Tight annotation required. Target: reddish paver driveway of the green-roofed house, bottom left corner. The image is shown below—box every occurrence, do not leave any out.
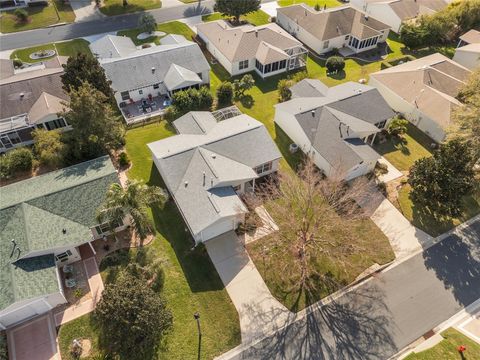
[7,313,61,360]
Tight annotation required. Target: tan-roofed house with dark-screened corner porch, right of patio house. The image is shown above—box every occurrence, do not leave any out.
[197,20,307,78]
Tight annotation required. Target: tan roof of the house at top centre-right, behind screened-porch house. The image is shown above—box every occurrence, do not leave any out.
[277,4,390,40]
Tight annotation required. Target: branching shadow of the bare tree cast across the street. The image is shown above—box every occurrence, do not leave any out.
[242,284,398,359]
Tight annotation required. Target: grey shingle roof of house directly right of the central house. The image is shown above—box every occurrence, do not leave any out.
[275,79,395,173]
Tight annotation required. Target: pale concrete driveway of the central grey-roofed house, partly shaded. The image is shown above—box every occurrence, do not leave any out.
[205,231,295,343]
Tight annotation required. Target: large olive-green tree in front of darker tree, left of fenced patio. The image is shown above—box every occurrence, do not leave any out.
[61,82,125,159]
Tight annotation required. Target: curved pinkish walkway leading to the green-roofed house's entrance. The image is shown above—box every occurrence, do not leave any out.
[54,257,104,326]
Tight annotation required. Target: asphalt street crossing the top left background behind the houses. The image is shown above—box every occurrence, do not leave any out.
[0,0,214,51]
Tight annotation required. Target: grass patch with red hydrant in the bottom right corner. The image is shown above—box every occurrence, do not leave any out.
[405,328,480,360]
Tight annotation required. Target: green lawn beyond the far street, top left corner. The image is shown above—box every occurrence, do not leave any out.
[0,0,75,33]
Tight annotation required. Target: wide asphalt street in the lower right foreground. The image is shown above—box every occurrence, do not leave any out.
[232,220,480,360]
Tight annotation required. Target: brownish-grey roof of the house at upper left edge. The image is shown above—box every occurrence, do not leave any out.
[0,60,69,119]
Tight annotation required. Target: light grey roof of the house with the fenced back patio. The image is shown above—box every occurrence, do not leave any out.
[94,35,210,92]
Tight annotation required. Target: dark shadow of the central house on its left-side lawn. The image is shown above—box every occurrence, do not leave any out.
[150,163,224,292]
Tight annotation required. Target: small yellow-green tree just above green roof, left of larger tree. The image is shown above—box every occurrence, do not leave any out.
[32,129,66,167]
